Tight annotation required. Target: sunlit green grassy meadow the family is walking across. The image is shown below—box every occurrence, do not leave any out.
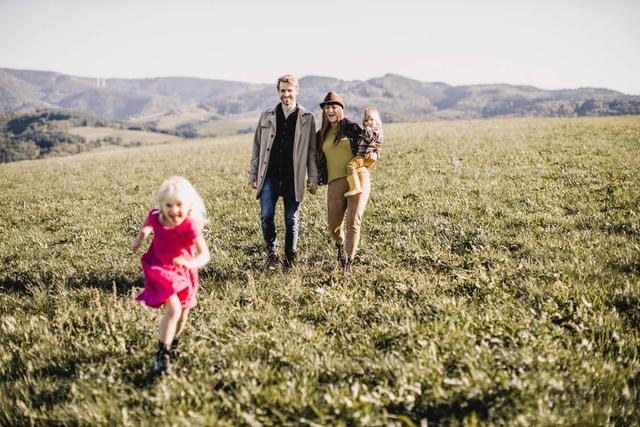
[0,117,640,427]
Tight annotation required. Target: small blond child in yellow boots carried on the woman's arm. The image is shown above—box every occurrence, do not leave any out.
[344,108,383,197]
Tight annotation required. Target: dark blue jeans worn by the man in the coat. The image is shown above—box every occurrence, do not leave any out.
[260,177,300,262]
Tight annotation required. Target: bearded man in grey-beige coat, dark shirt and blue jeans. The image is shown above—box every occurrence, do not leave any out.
[249,75,318,273]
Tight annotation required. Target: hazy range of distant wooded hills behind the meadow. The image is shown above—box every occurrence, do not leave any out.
[0,68,640,131]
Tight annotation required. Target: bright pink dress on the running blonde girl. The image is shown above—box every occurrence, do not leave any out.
[136,209,202,308]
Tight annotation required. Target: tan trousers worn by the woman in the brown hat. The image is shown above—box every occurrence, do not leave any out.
[327,171,371,259]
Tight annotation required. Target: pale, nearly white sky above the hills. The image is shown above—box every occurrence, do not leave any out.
[0,0,640,95]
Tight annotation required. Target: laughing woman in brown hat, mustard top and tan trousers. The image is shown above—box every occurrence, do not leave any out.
[317,92,377,273]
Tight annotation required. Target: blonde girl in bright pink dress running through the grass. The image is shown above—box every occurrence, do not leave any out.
[131,176,210,374]
